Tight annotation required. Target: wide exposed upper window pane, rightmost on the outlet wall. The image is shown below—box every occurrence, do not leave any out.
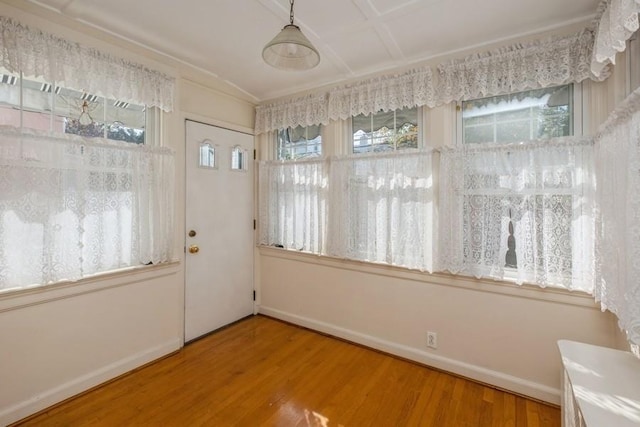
[462,85,574,144]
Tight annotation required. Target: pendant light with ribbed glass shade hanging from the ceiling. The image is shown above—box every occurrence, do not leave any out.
[262,0,320,71]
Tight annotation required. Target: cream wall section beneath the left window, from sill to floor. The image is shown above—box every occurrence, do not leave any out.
[0,263,183,425]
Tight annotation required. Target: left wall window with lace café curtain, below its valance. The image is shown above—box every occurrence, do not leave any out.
[0,69,172,291]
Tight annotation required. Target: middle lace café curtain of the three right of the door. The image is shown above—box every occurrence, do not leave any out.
[327,151,433,271]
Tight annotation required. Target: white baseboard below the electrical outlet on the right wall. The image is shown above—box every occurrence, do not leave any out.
[258,306,560,405]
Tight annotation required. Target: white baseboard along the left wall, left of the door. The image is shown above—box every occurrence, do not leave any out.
[0,338,182,426]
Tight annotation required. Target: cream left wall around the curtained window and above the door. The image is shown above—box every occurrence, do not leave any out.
[0,0,254,425]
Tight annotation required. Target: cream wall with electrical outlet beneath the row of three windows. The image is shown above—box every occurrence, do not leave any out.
[259,248,615,404]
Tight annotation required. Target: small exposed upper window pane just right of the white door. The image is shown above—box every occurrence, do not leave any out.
[276,125,322,160]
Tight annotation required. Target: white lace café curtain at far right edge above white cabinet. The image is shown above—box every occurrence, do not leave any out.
[594,89,640,350]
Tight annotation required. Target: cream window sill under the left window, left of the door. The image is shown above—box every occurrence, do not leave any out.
[0,261,180,313]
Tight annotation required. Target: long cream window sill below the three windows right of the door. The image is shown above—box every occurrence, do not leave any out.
[258,246,600,310]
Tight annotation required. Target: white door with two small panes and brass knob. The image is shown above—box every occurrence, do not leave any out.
[185,120,254,341]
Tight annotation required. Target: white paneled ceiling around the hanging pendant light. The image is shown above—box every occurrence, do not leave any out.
[22,0,600,101]
